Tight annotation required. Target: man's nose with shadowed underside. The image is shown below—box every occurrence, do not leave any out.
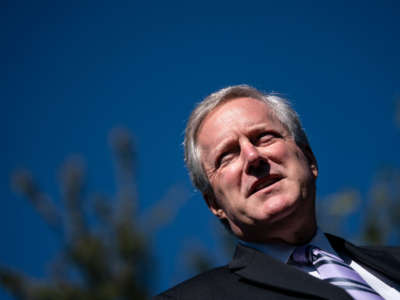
[242,141,269,177]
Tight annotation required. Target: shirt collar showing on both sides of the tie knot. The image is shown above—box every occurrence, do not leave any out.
[239,228,337,263]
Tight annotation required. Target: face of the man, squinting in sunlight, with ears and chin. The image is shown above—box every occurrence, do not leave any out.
[197,98,318,243]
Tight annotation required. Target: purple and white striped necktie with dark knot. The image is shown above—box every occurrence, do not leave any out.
[292,245,383,300]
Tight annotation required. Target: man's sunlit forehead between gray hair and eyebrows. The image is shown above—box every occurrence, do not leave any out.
[197,98,284,148]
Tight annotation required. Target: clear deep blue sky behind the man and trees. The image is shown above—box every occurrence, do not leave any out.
[0,1,400,300]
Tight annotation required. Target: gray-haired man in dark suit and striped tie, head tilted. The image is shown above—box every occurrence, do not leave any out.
[156,85,400,300]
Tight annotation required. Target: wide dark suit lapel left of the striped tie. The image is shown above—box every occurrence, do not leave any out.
[229,245,351,299]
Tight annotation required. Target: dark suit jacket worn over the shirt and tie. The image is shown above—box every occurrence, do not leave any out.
[154,235,400,300]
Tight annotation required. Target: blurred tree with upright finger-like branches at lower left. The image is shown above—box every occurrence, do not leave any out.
[0,129,177,300]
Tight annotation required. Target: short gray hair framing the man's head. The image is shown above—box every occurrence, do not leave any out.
[183,84,309,202]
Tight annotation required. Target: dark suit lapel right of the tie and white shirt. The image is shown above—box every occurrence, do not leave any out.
[326,234,400,283]
